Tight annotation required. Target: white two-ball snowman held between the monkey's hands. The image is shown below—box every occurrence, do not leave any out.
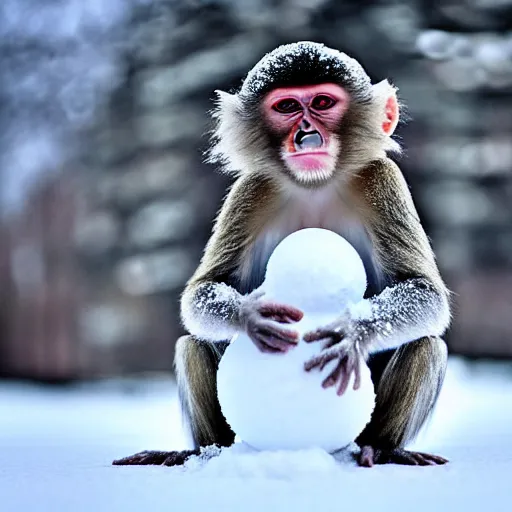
[217,229,375,452]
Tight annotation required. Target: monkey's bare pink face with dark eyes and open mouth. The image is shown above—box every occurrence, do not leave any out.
[263,84,350,185]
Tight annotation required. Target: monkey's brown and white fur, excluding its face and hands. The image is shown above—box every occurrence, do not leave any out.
[114,43,450,465]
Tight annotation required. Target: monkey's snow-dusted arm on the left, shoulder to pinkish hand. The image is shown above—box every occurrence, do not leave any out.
[181,174,302,351]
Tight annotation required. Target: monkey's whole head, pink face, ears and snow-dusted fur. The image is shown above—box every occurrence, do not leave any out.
[211,42,398,187]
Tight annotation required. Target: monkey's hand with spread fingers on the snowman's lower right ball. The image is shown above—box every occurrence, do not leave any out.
[304,315,367,396]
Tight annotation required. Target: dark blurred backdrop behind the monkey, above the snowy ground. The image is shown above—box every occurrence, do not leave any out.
[0,0,512,382]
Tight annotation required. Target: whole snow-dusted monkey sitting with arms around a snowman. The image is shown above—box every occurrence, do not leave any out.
[114,42,450,466]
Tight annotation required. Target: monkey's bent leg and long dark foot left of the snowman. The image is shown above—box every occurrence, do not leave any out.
[113,336,235,466]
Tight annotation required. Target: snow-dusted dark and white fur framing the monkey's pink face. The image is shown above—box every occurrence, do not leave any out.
[208,42,400,185]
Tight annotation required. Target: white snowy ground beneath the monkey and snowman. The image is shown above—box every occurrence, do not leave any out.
[0,359,512,512]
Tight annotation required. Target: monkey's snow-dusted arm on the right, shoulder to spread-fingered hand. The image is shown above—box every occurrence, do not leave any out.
[306,159,450,372]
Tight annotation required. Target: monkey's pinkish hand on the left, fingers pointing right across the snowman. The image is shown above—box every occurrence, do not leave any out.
[240,292,304,353]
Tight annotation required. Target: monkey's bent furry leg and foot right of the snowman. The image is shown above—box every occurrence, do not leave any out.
[356,336,448,467]
